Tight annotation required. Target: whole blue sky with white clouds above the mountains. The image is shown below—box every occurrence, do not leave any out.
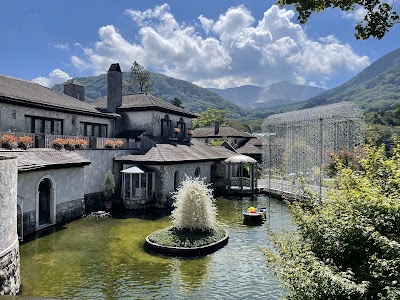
[0,0,400,88]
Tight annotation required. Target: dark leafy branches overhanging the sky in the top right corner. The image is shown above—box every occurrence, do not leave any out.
[277,0,399,40]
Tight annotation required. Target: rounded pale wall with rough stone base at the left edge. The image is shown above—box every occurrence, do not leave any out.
[0,157,21,295]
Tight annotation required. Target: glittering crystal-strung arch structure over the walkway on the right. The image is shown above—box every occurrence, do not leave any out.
[263,102,364,200]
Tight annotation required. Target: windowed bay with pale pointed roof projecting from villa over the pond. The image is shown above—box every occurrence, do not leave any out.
[121,166,155,209]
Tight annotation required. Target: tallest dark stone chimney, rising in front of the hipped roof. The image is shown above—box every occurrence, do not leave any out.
[107,63,122,112]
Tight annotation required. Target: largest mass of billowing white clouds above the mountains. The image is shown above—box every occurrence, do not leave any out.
[67,4,370,87]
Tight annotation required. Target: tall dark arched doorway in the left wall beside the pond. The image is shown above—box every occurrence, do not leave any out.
[36,176,55,227]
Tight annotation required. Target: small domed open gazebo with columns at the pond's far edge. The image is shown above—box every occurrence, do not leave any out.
[224,154,257,194]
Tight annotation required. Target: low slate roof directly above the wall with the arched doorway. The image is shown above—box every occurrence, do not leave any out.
[0,149,90,172]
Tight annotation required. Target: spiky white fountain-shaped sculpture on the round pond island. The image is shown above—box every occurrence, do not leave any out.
[171,177,217,231]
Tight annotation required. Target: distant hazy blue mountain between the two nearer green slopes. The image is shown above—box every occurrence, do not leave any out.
[208,81,326,109]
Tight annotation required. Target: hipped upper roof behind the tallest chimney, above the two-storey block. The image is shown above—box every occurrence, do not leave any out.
[91,94,197,118]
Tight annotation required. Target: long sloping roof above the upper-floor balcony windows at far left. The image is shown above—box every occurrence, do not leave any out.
[0,75,119,117]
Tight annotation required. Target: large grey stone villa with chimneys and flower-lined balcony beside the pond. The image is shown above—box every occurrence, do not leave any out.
[0,64,236,235]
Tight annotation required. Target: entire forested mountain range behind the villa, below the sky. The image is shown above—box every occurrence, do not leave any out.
[53,49,400,120]
